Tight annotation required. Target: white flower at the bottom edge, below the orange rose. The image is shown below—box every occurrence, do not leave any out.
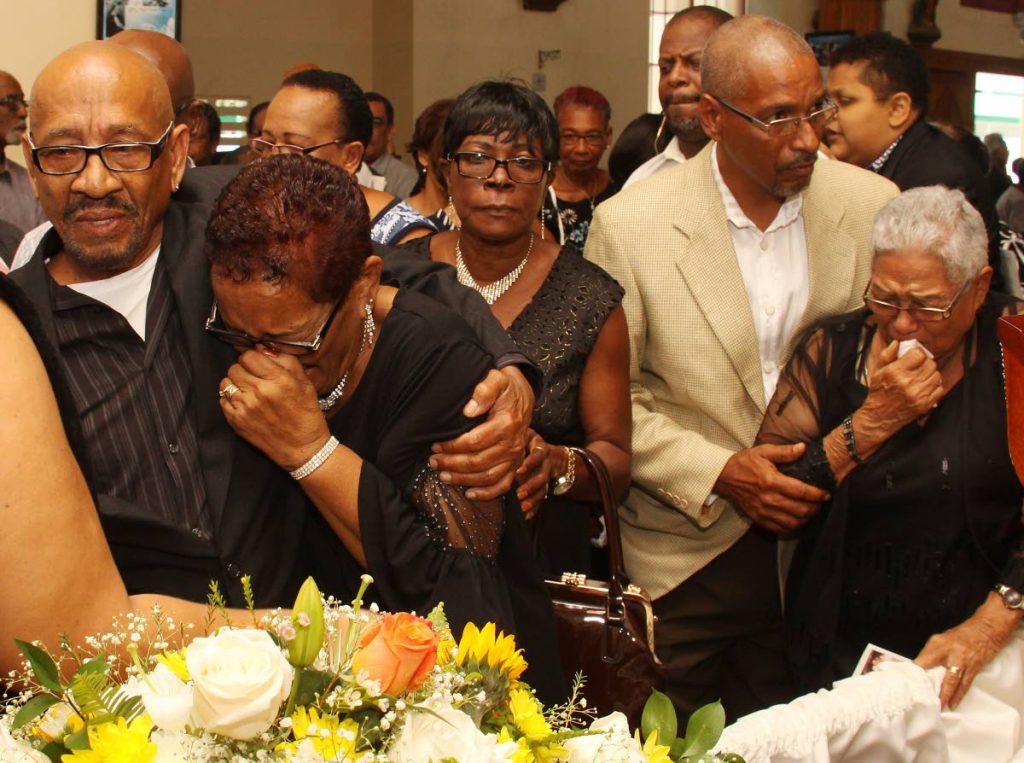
[388,700,517,763]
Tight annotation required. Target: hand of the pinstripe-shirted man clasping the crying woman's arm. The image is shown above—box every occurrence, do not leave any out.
[430,367,534,501]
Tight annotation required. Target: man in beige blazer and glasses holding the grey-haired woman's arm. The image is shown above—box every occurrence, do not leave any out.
[586,16,898,718]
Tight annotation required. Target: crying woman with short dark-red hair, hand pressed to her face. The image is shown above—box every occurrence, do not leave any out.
[201,156,559,696]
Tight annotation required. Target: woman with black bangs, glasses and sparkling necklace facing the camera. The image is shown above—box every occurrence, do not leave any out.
[408,82,631,576]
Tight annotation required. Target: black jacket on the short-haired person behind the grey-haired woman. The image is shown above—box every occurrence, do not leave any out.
[880,120,1004,291]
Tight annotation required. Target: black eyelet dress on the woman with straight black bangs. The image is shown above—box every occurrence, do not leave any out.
[509,247,625,579]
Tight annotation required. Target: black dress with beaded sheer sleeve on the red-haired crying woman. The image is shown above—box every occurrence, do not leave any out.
[301,291,564,700]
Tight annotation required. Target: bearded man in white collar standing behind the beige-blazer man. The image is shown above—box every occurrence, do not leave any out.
[623,5,732,187]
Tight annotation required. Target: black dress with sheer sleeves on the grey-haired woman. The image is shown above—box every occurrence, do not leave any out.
[758,294,1024,691]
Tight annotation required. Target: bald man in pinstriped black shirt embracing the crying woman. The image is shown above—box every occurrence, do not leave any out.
[11,42,534,605]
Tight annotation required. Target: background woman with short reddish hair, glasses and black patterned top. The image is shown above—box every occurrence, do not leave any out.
[543,85,618,252]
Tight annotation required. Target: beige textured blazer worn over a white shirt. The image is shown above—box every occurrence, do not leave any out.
[586,145,899,598]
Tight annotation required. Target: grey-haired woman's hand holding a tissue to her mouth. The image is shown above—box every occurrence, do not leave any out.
[860,341,945,435]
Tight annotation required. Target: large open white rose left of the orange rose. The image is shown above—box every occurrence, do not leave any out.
[185,628,292,739]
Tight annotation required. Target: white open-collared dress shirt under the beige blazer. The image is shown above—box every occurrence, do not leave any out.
[712,146,810,402]
